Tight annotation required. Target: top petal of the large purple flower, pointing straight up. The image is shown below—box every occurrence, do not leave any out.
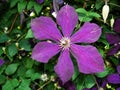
[57,5,78,37]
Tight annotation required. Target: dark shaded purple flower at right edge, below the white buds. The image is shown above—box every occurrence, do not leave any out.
[106,18,120,56]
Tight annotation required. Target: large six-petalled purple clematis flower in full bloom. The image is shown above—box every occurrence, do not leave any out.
[31,5,104,83]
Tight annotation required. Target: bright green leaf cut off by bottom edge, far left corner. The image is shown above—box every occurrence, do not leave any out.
[2,79,19,90]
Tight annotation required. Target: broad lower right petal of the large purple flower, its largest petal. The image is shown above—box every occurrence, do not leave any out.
[71,44,104,74]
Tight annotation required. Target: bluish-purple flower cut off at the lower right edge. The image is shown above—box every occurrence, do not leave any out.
[107,66,120,90]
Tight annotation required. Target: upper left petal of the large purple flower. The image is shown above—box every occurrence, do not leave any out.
[31,16,62,41]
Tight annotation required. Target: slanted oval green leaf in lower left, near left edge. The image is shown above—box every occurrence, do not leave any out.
[5,63,19,75]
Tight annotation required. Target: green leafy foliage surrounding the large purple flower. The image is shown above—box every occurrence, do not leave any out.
[0,0,120,90]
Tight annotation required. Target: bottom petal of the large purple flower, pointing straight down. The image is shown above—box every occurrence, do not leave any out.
[54,49,74,83]
